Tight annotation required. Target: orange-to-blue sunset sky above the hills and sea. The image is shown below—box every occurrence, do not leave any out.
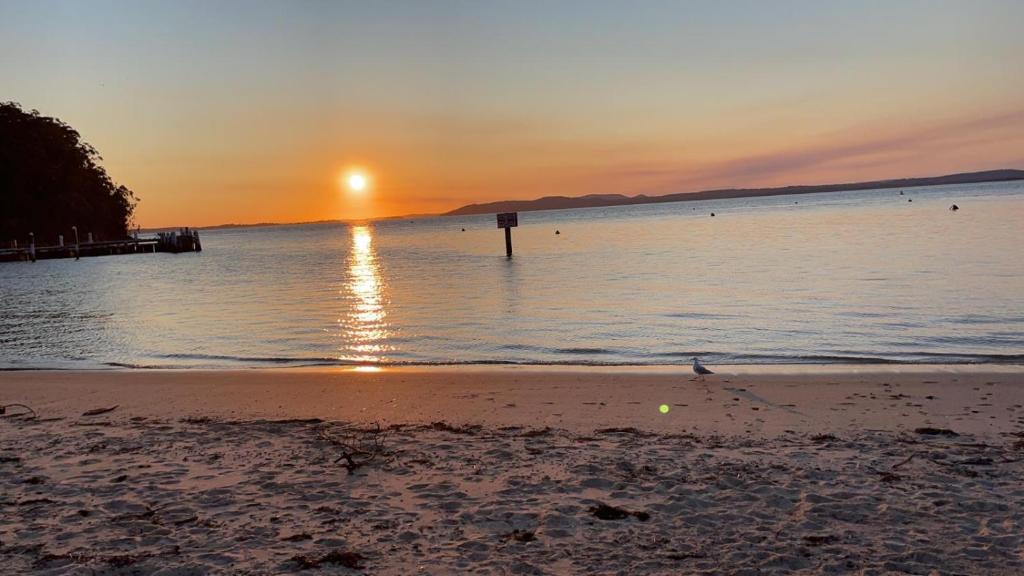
[0,0,1024,227]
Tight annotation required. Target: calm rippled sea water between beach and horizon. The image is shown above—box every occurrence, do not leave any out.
[0,182,1024,369]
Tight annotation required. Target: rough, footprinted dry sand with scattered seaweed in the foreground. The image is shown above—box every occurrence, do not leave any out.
[0,417,1024,575]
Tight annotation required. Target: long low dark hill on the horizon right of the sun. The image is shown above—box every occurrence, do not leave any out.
[444,169,1024,216]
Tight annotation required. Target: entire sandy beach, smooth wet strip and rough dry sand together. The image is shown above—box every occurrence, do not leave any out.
[0,366,1024,575]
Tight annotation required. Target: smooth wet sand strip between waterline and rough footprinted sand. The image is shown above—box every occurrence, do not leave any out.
[0,365,1024,437]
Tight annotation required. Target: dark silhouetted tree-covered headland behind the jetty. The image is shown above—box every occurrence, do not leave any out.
[0,102,137,241]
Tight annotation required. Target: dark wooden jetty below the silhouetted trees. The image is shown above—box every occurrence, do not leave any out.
[0,228,203,262]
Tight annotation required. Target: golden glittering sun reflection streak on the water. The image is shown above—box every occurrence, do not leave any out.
[338,225,388,363]
